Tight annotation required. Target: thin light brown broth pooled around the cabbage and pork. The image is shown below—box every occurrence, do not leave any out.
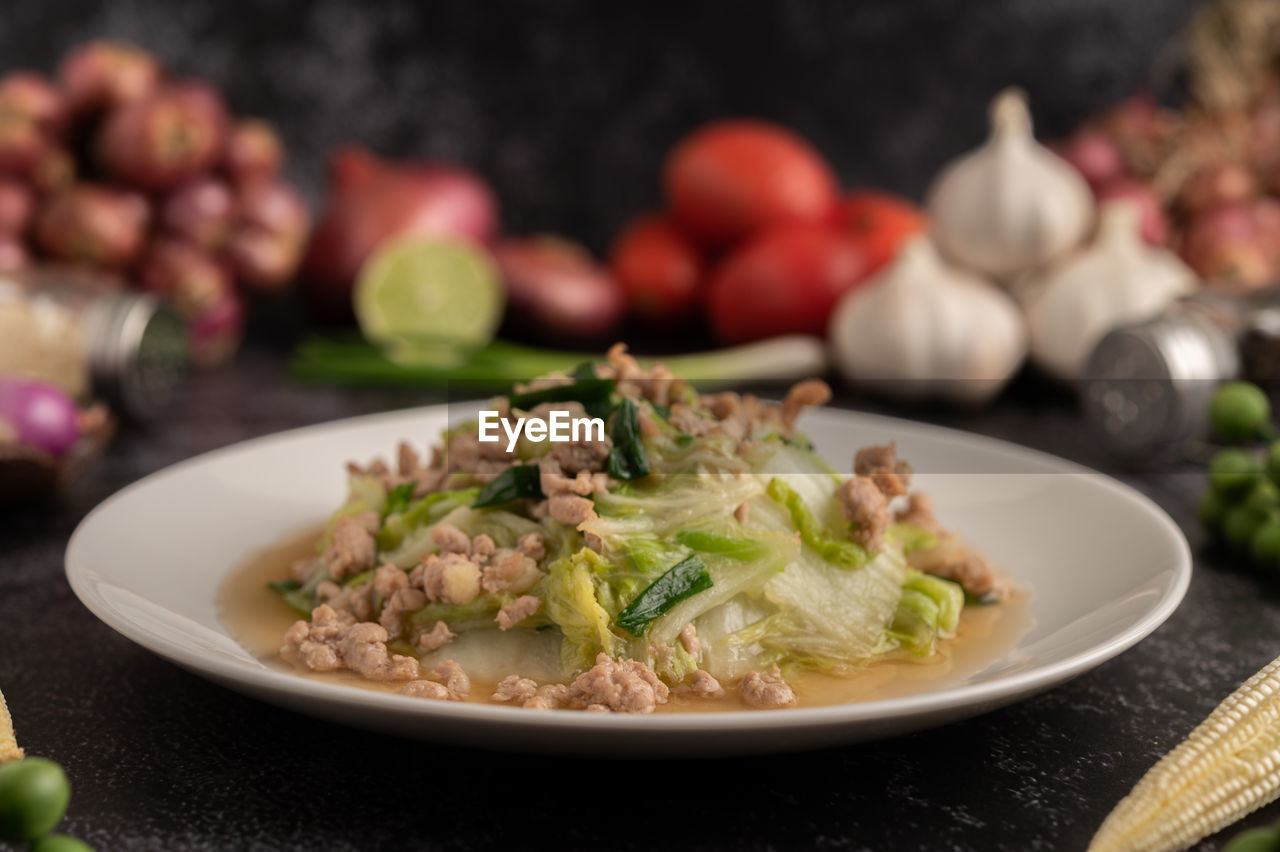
[218,525,1034,713]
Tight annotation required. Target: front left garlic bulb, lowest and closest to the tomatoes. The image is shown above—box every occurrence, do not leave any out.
[828,237,1027,402]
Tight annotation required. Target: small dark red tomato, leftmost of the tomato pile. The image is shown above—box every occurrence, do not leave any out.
[609,216,703,321]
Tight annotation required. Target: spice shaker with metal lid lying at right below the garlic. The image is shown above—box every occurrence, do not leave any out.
[1079,288,1280,462]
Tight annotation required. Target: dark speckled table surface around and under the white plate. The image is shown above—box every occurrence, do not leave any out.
[0,342,1280,849]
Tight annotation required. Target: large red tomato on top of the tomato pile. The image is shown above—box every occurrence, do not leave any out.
[663,119,838,246]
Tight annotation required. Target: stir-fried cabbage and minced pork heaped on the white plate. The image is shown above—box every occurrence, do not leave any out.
[271,344,1007,713]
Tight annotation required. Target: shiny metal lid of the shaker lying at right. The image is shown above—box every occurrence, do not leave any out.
[1080,313,1239,459]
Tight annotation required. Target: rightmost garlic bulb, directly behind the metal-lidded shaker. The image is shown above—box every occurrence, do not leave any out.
[1025,201,1196,379]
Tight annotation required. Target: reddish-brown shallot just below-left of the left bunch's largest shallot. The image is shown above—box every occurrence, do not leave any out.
[36,183,151,269]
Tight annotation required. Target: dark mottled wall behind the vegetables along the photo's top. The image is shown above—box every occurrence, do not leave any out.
[0,0,1194,249]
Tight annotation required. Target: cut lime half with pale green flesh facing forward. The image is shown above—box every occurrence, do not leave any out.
[352,238,504,363]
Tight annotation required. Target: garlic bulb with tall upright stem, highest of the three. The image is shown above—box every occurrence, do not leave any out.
[928,88,1093,281]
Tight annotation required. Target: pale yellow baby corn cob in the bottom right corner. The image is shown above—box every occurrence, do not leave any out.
[1089,649,1280,852]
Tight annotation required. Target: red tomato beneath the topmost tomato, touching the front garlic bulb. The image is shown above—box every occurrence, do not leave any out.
[708,225,870,343]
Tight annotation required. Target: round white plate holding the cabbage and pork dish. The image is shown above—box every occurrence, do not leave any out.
[67,407,1190,755]
